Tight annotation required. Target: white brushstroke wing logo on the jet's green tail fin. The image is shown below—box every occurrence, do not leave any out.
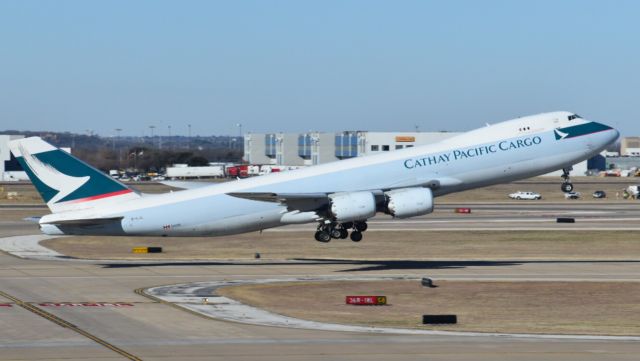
[20,146,91,203]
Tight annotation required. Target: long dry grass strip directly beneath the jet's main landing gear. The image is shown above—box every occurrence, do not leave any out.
[43,230,640,260]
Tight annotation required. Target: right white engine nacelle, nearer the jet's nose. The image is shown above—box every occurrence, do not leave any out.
[385,188,433,218]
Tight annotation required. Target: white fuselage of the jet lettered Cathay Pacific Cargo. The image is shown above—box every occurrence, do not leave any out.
[41,112,618,236]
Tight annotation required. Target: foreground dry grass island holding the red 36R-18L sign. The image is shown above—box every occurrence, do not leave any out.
[218,281,640,335]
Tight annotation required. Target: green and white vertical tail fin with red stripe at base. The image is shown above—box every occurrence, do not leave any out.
[9,137,140,213]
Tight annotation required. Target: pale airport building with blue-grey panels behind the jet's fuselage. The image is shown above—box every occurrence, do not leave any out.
[244,131,460,166]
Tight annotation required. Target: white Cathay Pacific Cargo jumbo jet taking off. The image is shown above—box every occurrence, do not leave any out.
[9,111,619,242]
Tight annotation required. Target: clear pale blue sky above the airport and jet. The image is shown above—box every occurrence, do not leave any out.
[0,0,640,135]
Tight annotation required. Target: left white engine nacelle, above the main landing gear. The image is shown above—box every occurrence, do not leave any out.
[329,192,376,222]
